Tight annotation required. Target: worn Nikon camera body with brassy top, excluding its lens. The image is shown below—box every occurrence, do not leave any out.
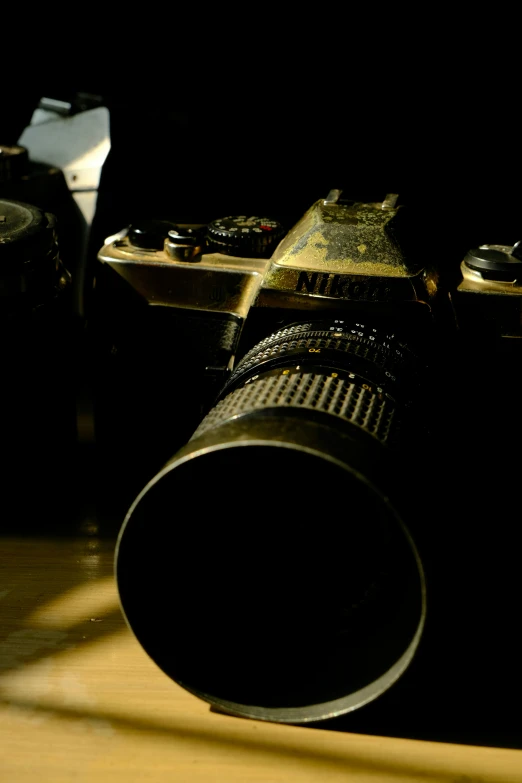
[92,190,522,512]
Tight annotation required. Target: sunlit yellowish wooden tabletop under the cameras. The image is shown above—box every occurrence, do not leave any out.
[0,521,522,783]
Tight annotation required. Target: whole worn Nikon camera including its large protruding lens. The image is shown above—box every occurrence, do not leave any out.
[94,190,522,723]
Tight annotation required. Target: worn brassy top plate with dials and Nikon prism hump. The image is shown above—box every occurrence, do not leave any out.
[98,191,441,350]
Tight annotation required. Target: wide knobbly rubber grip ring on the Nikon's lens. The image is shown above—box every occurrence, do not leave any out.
[192,369,399,446]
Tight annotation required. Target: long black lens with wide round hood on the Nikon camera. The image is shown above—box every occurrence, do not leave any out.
[117,320,425,723]
